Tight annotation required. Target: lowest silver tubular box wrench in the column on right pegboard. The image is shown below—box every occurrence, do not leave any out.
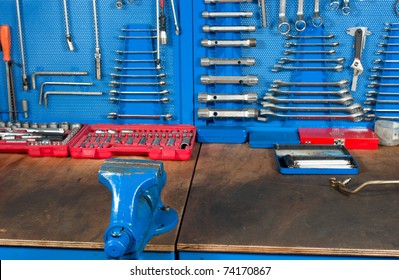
[197,108,258,119]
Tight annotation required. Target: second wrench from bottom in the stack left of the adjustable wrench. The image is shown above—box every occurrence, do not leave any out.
[261,102,363,114]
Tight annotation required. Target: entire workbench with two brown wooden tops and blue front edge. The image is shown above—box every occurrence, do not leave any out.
[0,144,399,259]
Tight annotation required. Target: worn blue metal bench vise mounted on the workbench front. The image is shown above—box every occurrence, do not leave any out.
[98,159,178,259]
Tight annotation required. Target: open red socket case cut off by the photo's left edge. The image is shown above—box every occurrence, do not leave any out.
[0,122,82,157]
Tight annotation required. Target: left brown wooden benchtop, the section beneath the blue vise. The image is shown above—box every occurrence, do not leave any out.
[0,145,199,252]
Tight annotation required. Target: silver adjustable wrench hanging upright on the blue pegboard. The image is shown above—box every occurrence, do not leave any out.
[346,27,371,91]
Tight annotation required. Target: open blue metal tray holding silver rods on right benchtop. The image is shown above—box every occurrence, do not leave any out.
[274,145,359,175]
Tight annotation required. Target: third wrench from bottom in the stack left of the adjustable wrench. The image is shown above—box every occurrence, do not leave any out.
[263,94,354,106]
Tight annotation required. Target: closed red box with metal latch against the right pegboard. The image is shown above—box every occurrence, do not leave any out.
[298,128,378,150]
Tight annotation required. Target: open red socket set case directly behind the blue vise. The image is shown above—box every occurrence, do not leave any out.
[69,124,196,160]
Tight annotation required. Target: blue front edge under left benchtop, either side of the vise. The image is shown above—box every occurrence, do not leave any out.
[0,246,175,260]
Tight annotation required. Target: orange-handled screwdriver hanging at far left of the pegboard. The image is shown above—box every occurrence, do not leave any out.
[0,25,18,122]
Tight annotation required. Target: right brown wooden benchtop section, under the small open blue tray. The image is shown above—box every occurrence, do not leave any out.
[177,145,399,257]
